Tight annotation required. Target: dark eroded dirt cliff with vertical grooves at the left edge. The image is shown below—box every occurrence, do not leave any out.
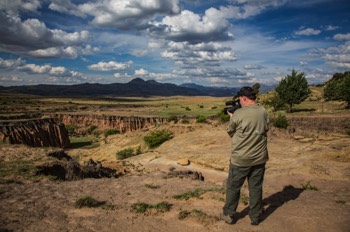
[0,118,70,148]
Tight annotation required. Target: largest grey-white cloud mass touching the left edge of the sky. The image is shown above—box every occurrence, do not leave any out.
[0,11,89,57]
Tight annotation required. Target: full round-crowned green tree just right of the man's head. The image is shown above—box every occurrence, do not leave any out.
[276,69,311,112]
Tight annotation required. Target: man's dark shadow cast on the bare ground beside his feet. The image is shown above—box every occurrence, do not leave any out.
[239,185,304,222]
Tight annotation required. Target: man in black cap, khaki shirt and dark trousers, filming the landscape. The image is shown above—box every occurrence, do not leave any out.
[221,87,269,225]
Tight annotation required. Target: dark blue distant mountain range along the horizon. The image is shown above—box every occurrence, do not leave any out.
[0,78,274,97]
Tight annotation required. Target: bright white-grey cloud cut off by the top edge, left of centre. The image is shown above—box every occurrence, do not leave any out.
[49,0,180,30]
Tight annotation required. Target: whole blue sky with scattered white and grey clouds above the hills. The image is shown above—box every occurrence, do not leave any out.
[0,0,350,87]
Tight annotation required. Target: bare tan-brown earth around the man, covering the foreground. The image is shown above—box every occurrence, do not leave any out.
[0,124,350,232]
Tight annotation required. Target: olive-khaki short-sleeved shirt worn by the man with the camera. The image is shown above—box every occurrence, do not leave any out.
[227,104,269,167]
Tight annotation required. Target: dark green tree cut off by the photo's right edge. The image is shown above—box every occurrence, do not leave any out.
[324,72,350,107]
